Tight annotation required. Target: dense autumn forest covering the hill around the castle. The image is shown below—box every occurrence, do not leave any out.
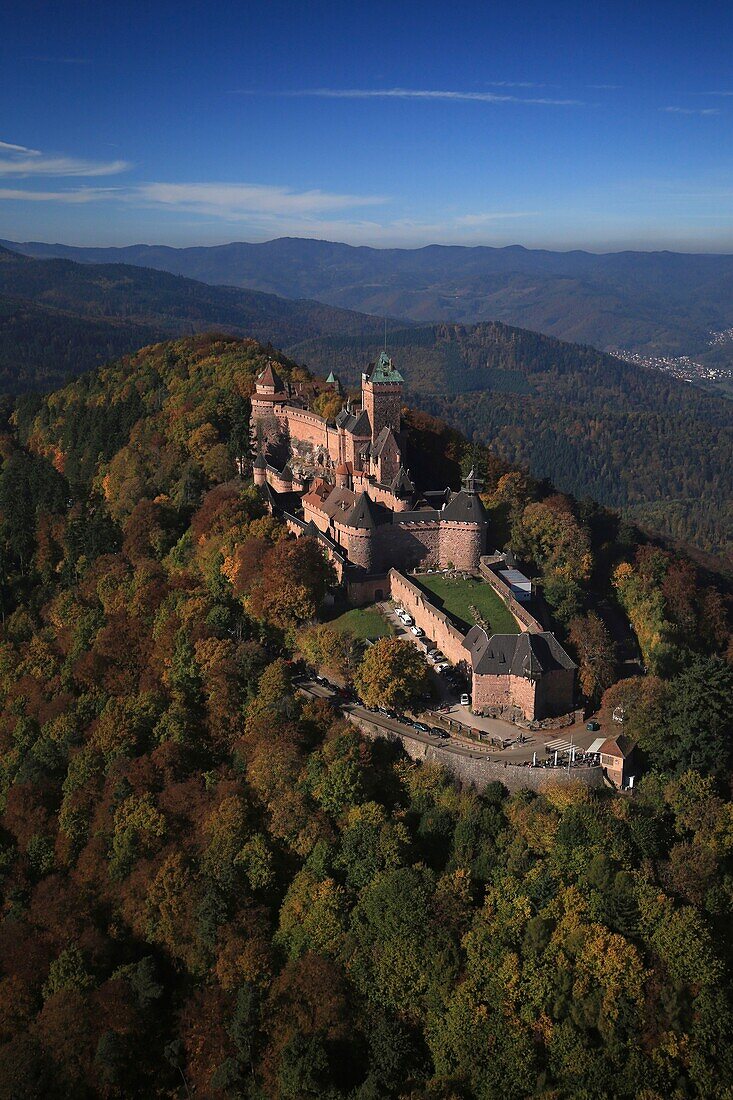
[0,337,733,1100]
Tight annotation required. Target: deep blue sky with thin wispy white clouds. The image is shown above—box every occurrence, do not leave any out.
[0,0,733,252]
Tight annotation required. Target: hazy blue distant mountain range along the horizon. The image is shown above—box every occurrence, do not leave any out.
[8,238,733,354]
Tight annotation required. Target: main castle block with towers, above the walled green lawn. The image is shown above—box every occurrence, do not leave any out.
[251,352,488,596]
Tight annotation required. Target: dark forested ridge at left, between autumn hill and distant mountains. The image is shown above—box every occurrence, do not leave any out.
[0,248,383,393]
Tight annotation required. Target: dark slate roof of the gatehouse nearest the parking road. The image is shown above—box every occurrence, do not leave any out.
[463,626,576,678]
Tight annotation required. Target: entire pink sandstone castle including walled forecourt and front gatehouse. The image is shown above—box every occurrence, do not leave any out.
[251,352,576,721]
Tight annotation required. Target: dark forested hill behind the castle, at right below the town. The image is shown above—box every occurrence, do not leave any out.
[289,323,733,560]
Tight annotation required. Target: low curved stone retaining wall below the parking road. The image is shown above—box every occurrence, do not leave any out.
[352,712,604,791]
